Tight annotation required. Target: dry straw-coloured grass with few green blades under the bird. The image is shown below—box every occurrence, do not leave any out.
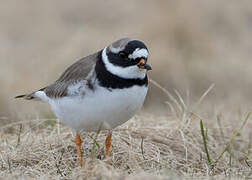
[0,81,252,179]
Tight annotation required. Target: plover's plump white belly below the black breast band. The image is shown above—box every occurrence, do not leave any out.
[48,86,147,132]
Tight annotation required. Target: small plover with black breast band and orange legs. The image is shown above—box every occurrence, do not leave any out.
[15,38,152,166]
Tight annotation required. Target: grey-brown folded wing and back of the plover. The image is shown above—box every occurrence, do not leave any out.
[41,52,100,98]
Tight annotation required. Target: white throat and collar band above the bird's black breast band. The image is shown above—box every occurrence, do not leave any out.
[102,47,147,79]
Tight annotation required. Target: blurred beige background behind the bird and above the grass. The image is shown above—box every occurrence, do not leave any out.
[0,0,252,122]
